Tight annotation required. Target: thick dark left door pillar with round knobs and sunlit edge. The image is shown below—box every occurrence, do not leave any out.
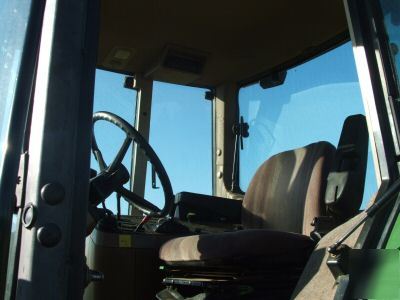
[9,0,99,299]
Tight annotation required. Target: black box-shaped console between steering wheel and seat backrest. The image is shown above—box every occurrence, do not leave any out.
[174,192,242,224]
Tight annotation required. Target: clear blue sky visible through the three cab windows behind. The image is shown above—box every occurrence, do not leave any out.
[92,43,376,212]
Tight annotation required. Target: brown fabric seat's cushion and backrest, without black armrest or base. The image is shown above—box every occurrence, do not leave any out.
[160,142,336,272]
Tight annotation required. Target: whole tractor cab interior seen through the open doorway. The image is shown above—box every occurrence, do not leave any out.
[84,0,380,300]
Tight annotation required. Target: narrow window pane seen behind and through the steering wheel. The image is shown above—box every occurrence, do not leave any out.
[91,70,136,215]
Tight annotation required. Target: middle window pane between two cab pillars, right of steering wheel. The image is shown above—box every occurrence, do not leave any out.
[145,82,212,208]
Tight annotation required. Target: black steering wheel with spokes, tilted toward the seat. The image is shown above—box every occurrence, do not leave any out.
[92,111,174,217]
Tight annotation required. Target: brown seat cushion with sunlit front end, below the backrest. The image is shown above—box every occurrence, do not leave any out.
[160,229,315,267]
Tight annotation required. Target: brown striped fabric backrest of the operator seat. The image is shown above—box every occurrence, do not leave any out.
[242,142,336,235]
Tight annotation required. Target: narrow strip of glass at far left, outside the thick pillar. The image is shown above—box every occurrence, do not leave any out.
[0,0,37,290]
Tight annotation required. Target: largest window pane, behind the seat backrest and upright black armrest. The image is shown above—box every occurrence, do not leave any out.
[239,43,377,207]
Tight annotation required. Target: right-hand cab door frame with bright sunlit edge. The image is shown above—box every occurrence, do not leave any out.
[344,0,400,253]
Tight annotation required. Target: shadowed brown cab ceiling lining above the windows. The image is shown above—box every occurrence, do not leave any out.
[98,0,348,87]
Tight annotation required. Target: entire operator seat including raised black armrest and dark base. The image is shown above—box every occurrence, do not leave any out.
[160,115,368,299]
